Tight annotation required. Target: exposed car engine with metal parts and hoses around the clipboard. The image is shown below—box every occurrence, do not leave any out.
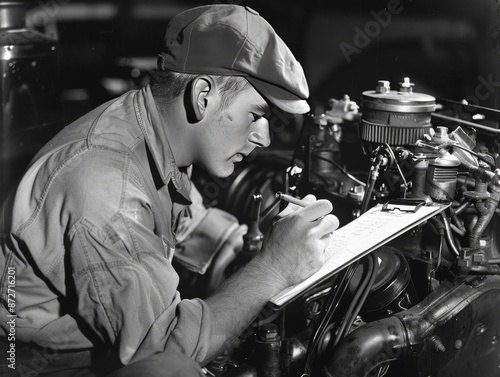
[185,77,500,377]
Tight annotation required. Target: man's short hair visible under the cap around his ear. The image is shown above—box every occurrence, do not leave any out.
[150,70,251,106]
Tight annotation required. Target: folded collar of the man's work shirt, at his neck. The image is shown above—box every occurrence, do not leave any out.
[134,85,191,201]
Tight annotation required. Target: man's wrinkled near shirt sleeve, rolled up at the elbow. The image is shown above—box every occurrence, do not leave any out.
[62,150,211,364]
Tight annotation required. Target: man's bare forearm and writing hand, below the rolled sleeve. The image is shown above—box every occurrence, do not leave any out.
[205,195,339,359]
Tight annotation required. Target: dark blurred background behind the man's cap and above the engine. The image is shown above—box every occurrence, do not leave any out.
[0,0,500,200]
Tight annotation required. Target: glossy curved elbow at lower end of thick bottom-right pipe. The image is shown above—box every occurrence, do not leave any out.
[324,317,408,377]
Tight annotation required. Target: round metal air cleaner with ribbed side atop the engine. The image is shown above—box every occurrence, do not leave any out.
[360,77,436,145]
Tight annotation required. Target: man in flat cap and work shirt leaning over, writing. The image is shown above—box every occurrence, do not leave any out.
[0,5,338,376]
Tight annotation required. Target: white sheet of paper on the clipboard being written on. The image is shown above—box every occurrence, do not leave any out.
[270,204,449,307]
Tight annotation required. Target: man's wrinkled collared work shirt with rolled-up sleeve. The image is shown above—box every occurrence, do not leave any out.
[0,86,211,364]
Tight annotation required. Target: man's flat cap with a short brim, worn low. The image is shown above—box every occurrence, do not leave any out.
[158,4,310,114]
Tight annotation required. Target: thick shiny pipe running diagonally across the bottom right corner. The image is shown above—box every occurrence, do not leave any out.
[323,276,500,377]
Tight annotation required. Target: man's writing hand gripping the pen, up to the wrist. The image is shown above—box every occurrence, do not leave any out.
[261,195,339,288]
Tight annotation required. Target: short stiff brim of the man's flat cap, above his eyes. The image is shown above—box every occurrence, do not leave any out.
[246,76,311,114]
